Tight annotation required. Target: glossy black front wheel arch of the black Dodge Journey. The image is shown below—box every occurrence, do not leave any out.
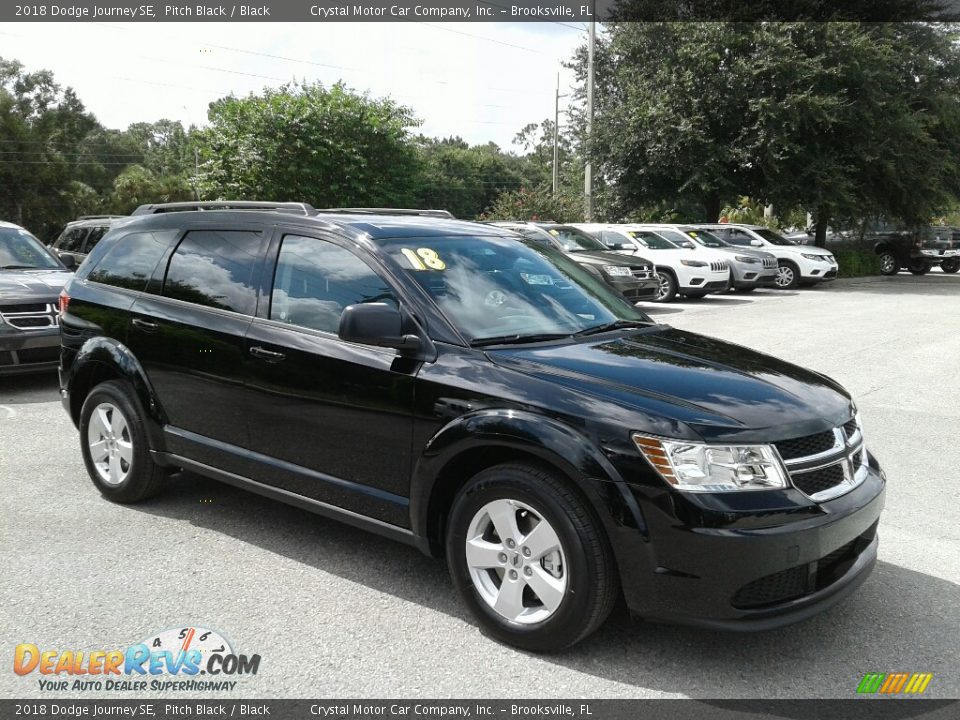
[410,408,646,546]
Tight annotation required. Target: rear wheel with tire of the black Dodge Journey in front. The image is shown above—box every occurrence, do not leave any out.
[80,380,167,503]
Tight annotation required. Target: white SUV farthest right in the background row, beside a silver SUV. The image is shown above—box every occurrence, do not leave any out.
[696,223,837,290]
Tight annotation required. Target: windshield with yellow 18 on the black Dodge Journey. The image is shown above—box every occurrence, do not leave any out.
[384,236,651,344]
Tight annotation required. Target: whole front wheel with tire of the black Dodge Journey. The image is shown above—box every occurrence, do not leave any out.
[446,463,619,652]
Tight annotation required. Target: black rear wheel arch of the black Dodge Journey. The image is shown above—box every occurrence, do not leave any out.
[65,336,167,451]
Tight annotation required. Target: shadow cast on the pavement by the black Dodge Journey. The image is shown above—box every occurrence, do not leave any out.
[130,466,960,696]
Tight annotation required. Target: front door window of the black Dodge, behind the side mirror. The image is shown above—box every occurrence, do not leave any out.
[270,235,397,333]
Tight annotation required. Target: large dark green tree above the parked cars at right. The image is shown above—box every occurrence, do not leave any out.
[578,21,960,242]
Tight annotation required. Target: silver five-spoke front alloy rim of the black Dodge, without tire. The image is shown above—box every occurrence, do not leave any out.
[465,498,568,625]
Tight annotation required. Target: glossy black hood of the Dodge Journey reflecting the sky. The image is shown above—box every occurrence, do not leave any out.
[489,326,851,442]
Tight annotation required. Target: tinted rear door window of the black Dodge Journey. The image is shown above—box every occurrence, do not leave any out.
[163,230,263,315]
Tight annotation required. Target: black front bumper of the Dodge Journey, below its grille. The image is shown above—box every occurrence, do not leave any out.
[619,461,886,630]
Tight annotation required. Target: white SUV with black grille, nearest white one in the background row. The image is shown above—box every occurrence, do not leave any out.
[575,223,730,302]
